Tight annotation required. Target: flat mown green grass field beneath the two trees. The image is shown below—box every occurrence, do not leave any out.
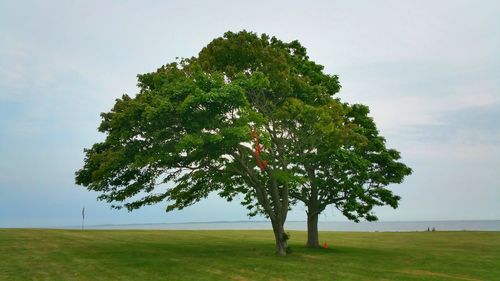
[0,229,500,281]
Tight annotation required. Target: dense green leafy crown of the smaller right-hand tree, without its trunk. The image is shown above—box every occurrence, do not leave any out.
[289,100,412,221]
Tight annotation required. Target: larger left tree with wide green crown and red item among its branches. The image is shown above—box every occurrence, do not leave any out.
[76,32,338,255]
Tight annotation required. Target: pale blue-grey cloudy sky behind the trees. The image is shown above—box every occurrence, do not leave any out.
[0,0,500,227]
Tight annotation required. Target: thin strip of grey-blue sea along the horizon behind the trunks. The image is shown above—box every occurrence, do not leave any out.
[82,220,500,232]
